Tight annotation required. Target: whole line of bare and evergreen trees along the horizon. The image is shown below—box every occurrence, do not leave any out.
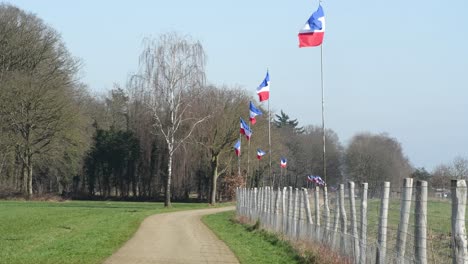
[0,4,466,206]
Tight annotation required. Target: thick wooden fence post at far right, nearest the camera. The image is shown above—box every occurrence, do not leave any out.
[451,180,468,264]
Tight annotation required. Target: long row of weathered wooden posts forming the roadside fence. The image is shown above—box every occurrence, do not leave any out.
[236,178,468,264]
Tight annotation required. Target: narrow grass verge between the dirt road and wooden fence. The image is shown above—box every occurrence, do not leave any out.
[203,211,300,263]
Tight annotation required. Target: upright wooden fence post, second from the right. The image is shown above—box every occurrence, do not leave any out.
[414,181,427,264]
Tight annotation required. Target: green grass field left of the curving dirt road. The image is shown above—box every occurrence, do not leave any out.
[0,201,216,263]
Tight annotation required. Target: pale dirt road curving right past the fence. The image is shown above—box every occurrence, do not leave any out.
[104,207,239,264]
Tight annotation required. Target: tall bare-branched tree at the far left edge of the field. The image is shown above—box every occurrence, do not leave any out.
[0,4,85,197]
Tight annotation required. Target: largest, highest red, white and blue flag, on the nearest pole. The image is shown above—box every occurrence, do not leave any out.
[298,5,325,48]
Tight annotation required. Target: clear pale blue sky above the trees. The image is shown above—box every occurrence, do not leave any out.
[8,0,468,170]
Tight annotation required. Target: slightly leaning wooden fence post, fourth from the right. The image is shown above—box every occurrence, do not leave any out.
[376,182,390,264]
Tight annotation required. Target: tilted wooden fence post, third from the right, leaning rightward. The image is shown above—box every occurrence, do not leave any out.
[395,178,413,264]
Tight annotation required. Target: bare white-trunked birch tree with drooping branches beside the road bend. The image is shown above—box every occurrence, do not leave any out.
[134,33,208,207]
